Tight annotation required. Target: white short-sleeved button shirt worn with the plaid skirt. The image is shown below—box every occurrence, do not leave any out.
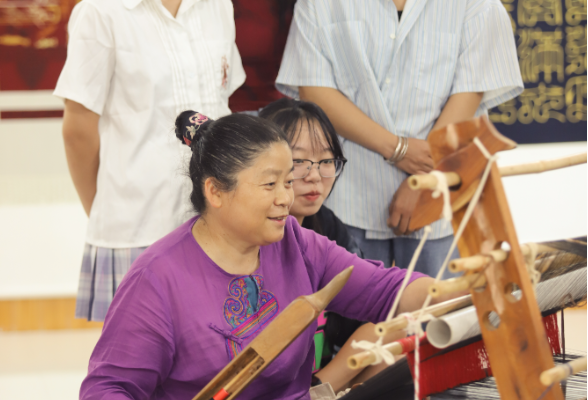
[55,0,245,248]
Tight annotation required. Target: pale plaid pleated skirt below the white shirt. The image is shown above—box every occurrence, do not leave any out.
[76,243,147,322]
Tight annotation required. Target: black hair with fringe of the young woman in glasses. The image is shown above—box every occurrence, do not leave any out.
[259,98,345,234]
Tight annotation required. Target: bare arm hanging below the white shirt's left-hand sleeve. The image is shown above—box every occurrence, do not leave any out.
[63,101,100,215]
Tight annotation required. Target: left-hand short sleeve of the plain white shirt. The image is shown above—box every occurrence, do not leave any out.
[53,1,115,115]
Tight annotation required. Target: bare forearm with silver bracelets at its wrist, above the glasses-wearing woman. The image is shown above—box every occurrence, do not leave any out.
[299,87,398,159]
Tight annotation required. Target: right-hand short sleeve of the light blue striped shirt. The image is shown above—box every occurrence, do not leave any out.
[451,0,524,110]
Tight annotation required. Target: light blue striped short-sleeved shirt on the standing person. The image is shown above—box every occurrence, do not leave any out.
[277,0,523,239]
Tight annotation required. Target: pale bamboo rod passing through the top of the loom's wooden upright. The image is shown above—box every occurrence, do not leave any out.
[408,153,588,190]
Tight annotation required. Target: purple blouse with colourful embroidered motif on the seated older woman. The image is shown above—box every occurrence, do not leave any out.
[80,217,424,400]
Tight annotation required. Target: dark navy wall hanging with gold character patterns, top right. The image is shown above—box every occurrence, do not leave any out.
[490,0,587,143]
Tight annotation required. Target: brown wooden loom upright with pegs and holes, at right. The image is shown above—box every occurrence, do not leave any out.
[382,117,586,400]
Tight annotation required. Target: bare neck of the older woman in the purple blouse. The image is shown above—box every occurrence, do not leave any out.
[192,217,260,275]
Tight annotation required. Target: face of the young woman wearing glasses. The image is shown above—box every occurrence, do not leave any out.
[290,124,335,222]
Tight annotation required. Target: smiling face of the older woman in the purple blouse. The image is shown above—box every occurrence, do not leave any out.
[217,143,294,246]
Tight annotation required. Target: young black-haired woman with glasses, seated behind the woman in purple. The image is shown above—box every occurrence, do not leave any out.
[260,99,406,391]
